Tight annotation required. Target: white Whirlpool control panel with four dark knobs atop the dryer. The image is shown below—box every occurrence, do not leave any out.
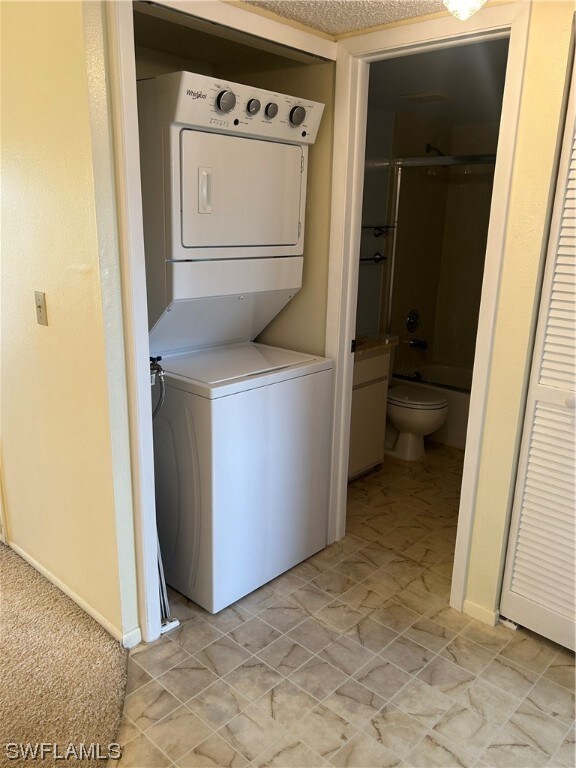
[154,72,324,144]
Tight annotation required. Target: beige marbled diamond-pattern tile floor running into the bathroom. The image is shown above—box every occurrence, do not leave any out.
[113,446,574,768]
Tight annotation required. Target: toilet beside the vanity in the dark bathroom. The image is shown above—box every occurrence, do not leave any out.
[385,384,448,461]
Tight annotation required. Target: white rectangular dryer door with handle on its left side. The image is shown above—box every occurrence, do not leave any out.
[180,129,305,254]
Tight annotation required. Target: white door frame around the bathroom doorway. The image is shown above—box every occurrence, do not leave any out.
[326,2,531,610]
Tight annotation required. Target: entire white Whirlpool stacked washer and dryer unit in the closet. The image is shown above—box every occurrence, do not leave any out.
[138,72,332,613]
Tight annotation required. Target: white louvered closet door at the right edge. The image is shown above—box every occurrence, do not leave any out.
[500,63,576,649]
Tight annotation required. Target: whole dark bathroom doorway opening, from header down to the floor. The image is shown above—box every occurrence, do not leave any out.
[347,38,508,616]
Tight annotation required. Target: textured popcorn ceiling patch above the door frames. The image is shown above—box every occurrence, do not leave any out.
[245,0,446,37]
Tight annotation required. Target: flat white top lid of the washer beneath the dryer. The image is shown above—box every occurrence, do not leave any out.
[162,342,315,386]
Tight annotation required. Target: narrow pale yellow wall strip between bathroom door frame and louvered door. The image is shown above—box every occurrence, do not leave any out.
[465,2,574,618]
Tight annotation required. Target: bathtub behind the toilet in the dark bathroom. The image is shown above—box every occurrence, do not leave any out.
[390,365,472,450]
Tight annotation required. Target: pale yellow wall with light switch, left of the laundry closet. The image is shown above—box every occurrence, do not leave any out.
[1,2,137,638]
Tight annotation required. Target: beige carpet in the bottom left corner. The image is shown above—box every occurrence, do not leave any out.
[0,543,128,768]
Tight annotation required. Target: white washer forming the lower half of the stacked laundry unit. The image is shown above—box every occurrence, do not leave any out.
[154,342,332,613]
